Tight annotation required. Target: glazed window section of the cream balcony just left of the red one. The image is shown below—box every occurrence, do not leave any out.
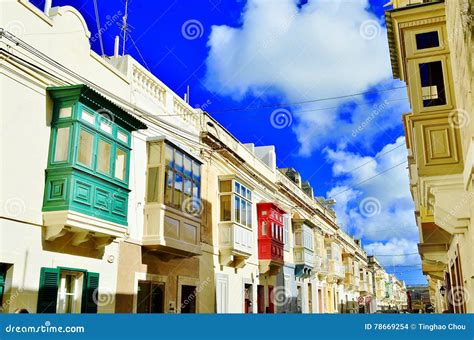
[219,179,252,227]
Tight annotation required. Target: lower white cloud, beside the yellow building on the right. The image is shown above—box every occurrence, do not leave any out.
[326,137,418,241]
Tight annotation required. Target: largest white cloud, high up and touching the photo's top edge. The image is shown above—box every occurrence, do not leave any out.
[206,0,406,155]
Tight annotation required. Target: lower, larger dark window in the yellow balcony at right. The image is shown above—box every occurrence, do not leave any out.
[419,61,446,107]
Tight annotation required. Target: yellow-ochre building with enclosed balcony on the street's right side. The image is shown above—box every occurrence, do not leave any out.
[386,0,474,313]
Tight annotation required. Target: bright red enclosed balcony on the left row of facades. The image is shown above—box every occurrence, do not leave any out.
[257,203,285,275]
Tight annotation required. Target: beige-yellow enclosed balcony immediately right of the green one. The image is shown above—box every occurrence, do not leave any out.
[142,138,203,257]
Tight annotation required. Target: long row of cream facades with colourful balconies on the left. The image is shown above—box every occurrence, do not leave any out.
[0,0,408,313]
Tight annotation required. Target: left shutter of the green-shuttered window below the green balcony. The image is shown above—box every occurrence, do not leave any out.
[36,268,59,313]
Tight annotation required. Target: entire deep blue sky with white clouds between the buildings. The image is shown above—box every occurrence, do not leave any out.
[32,0,425,283]
